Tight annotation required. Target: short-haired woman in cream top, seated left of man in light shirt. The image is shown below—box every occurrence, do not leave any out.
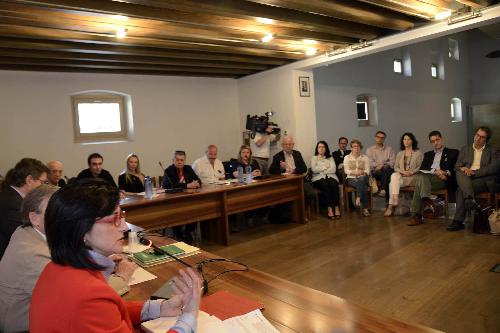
[344,139,370,216]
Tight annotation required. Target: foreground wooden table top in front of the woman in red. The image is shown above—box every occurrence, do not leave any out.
[125,236,439,333]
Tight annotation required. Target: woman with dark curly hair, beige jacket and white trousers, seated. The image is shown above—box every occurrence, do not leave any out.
[384,132,423,216]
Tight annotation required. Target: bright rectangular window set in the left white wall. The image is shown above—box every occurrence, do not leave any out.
[71,91,131,143]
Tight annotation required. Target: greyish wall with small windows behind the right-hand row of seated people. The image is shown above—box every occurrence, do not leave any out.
[314,34,470,150]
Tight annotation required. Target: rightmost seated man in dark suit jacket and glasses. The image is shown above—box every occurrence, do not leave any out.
[446,126,500,231]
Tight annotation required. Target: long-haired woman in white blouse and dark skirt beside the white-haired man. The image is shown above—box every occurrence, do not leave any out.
[311,141,340,219]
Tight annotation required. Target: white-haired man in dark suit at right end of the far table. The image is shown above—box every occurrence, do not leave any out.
[269,136,315,223]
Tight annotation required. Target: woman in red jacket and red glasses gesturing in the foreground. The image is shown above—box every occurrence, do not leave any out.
[30,179,201,333]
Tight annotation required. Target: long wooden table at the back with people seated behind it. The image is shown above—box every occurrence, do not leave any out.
[120,175,305,245]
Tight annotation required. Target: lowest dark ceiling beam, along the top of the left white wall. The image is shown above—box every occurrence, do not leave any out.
[0,56,255,75]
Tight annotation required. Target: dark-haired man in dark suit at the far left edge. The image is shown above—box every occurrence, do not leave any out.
[0,158,49,258]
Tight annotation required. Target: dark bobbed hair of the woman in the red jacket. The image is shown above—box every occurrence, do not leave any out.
[45,179,120,270]
